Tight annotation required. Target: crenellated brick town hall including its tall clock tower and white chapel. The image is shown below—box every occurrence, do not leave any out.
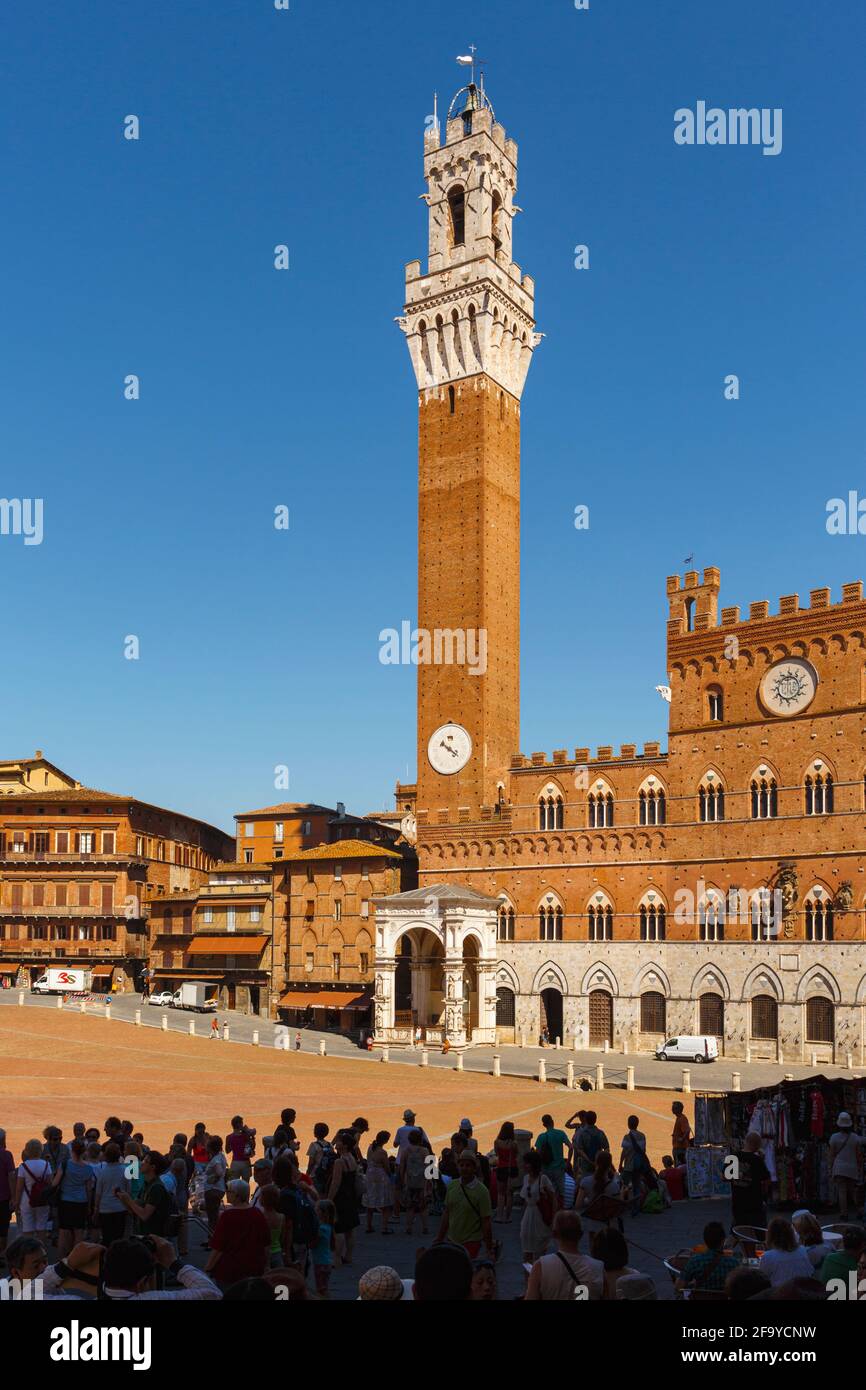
[375,73,866,1065]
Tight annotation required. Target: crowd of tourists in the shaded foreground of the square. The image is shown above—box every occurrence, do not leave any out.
[0,1101,866,1301]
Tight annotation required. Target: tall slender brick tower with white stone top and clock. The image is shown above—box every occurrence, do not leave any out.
[400,71,541,835]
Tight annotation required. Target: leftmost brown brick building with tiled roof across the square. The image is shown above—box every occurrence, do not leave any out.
[0,752,232,990]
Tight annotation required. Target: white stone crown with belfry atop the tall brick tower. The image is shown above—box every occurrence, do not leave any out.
[399,81,541,400]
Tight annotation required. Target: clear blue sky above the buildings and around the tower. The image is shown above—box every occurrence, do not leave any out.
[0,0,866,827]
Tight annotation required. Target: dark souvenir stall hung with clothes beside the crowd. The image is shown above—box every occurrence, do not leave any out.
[688,1076,866,1211]
